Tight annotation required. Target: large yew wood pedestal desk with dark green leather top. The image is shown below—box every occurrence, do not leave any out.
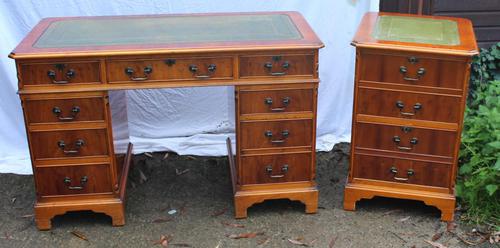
[10,12,323,230]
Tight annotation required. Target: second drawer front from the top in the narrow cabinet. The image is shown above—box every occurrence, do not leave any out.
[357,88,461,123]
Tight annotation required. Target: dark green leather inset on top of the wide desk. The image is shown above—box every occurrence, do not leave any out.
[33,14,302,48]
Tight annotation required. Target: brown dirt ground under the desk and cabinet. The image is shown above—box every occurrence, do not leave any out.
[0,143,496,248]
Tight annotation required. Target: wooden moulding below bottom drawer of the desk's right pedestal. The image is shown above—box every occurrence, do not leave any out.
[236,181,317,195]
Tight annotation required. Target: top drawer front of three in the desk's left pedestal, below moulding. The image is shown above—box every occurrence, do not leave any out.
[24,97,105,124]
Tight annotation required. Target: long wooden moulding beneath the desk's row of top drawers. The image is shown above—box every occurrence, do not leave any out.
[19,78,319,95]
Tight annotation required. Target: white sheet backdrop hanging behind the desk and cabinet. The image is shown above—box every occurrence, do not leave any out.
[0,0,379,174]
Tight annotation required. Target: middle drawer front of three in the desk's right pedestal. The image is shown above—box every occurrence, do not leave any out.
[240,119,313,149]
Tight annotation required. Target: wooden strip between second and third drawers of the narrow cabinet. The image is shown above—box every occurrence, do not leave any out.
[356,114,458,132]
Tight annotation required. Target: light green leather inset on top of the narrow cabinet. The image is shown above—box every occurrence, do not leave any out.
[372,15,460,46]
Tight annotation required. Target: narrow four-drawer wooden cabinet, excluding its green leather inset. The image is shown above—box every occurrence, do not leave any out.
[344,13,477,221]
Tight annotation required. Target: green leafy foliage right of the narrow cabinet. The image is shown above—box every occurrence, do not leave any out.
[456,43,500,229]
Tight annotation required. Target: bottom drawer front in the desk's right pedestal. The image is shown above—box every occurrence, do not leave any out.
[240,153,311,184]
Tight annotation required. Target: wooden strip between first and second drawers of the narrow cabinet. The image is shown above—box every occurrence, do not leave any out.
[358,80,463,97]
